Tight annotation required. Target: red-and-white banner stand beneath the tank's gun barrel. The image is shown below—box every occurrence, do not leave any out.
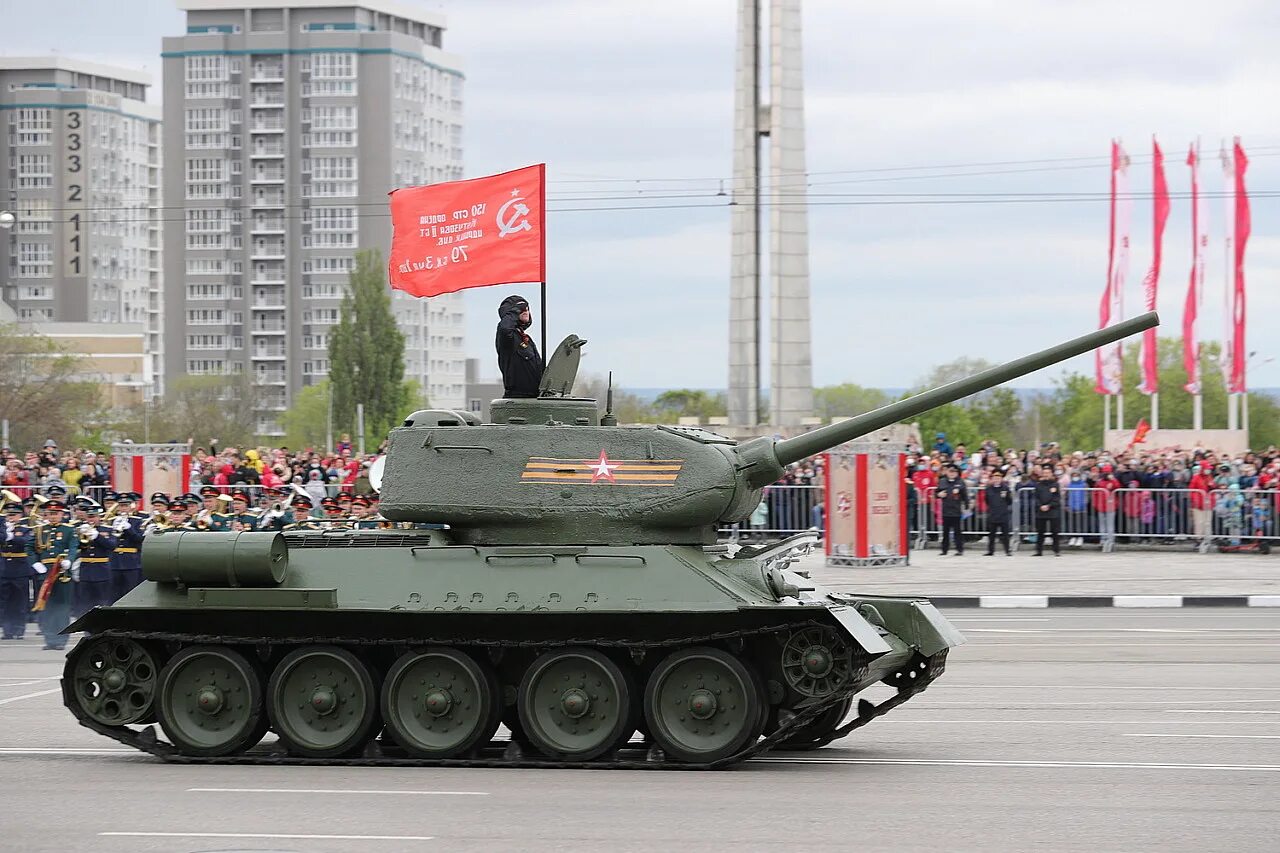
[823,441,910,566]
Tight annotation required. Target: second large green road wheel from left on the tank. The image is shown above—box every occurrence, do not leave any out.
[266,646,378,758]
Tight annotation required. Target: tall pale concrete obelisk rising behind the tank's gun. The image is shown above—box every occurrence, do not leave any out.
[728,0,813,427]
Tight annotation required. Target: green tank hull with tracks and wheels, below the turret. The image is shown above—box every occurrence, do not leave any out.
[63,532,964,768]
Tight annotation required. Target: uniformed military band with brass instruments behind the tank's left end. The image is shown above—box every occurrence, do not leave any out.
[0,485,394,649]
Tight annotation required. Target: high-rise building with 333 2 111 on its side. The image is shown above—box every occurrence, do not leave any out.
[0,56,164,396]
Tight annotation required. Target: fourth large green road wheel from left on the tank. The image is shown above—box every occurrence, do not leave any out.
[516,648,635,761]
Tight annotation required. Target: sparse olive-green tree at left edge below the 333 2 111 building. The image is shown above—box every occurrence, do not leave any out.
[0,324,104,448]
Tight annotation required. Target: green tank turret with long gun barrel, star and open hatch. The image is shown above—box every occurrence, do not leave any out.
[381,313,1160,546]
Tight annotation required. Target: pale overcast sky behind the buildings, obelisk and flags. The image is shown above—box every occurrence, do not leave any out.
[10,0,1280,387]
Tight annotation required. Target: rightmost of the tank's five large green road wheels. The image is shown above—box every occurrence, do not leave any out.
[644,646,768,763]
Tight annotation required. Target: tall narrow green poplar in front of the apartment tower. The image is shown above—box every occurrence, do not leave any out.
[329,250,412,443]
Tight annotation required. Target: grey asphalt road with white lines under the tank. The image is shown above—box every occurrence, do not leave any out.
[0,608,1280,853]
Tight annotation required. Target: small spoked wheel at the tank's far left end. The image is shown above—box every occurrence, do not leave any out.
[63,637,160,726]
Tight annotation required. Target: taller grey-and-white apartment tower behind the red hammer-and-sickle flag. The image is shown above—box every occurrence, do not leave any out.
[163,0,466,434]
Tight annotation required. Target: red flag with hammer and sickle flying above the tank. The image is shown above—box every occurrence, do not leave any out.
[388,164,547,296]
